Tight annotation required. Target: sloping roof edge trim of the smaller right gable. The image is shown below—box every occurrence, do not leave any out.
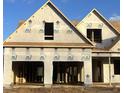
[76,8,120,36]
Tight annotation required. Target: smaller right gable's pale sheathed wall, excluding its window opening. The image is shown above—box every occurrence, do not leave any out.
[76,9,119,48]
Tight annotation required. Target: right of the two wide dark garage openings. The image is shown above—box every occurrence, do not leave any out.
[53,62,84,84]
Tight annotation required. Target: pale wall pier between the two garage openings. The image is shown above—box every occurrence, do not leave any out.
[44,59,53,85]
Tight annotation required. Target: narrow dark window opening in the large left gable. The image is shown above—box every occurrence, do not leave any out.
[45,22,54,40]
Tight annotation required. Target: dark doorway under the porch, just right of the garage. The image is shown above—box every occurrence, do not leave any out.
[92,60,103,82]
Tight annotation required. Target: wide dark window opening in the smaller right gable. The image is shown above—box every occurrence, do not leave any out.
[87,29,102,43]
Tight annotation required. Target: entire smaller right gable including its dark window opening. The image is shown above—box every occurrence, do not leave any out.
[76,9,119,48]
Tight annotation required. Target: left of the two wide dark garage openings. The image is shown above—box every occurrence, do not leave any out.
[12,62,44,84]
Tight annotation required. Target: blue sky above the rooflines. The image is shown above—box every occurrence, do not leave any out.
[3,0,120,40]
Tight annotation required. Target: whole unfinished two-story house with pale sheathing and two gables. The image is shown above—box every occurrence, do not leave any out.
[3,0,120,85]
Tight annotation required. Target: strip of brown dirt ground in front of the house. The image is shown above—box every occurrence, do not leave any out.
[3,86,120,93]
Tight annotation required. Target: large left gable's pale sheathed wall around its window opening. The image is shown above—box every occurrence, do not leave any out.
[5,1,92,46]
